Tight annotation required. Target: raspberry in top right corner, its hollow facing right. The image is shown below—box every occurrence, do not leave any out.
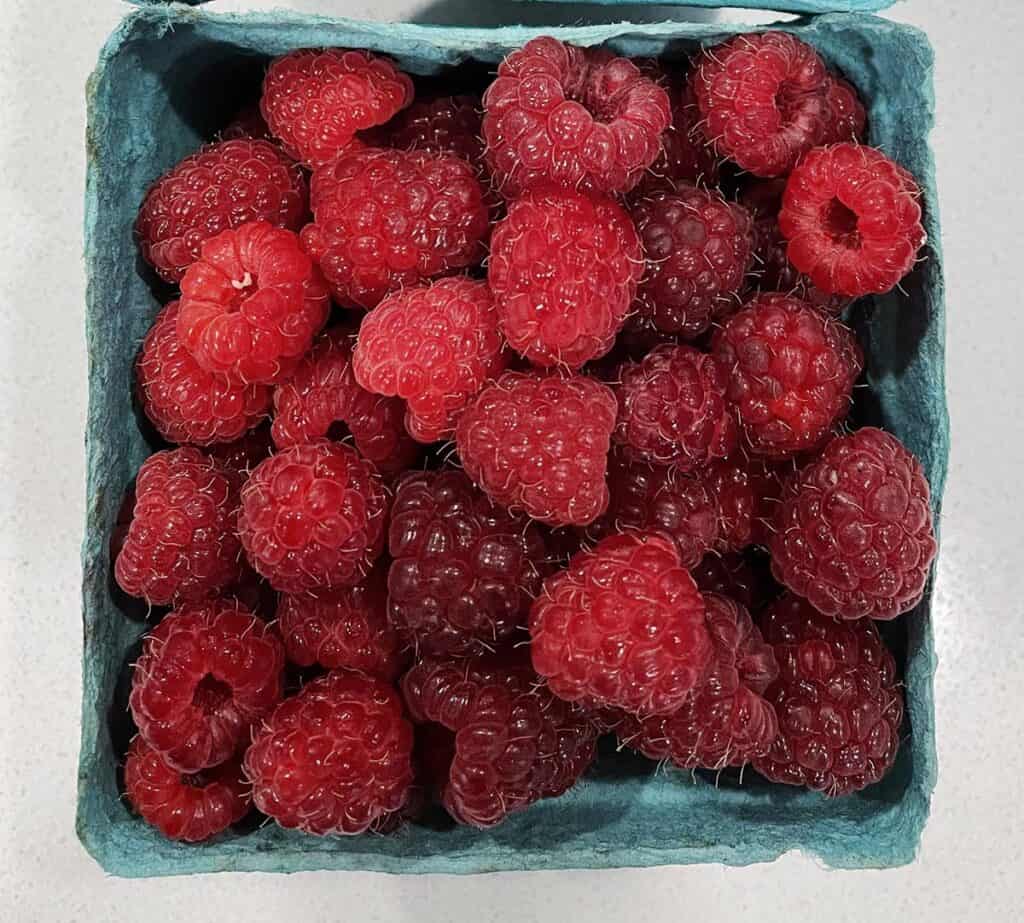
[690,32,843,176]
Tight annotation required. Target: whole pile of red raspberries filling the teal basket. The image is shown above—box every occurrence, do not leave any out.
[112,32,936,841]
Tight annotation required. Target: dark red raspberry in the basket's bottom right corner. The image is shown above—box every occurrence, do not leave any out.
[754,595,903,797]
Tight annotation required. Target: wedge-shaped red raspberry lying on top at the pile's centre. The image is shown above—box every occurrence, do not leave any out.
[456,372,616,526]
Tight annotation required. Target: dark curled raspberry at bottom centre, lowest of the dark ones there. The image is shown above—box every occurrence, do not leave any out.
[401,655,597,828]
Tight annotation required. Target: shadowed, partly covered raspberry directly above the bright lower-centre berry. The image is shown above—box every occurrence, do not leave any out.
[587,453,719,568]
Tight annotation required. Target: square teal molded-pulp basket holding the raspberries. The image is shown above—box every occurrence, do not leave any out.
[78,0,948,877]
